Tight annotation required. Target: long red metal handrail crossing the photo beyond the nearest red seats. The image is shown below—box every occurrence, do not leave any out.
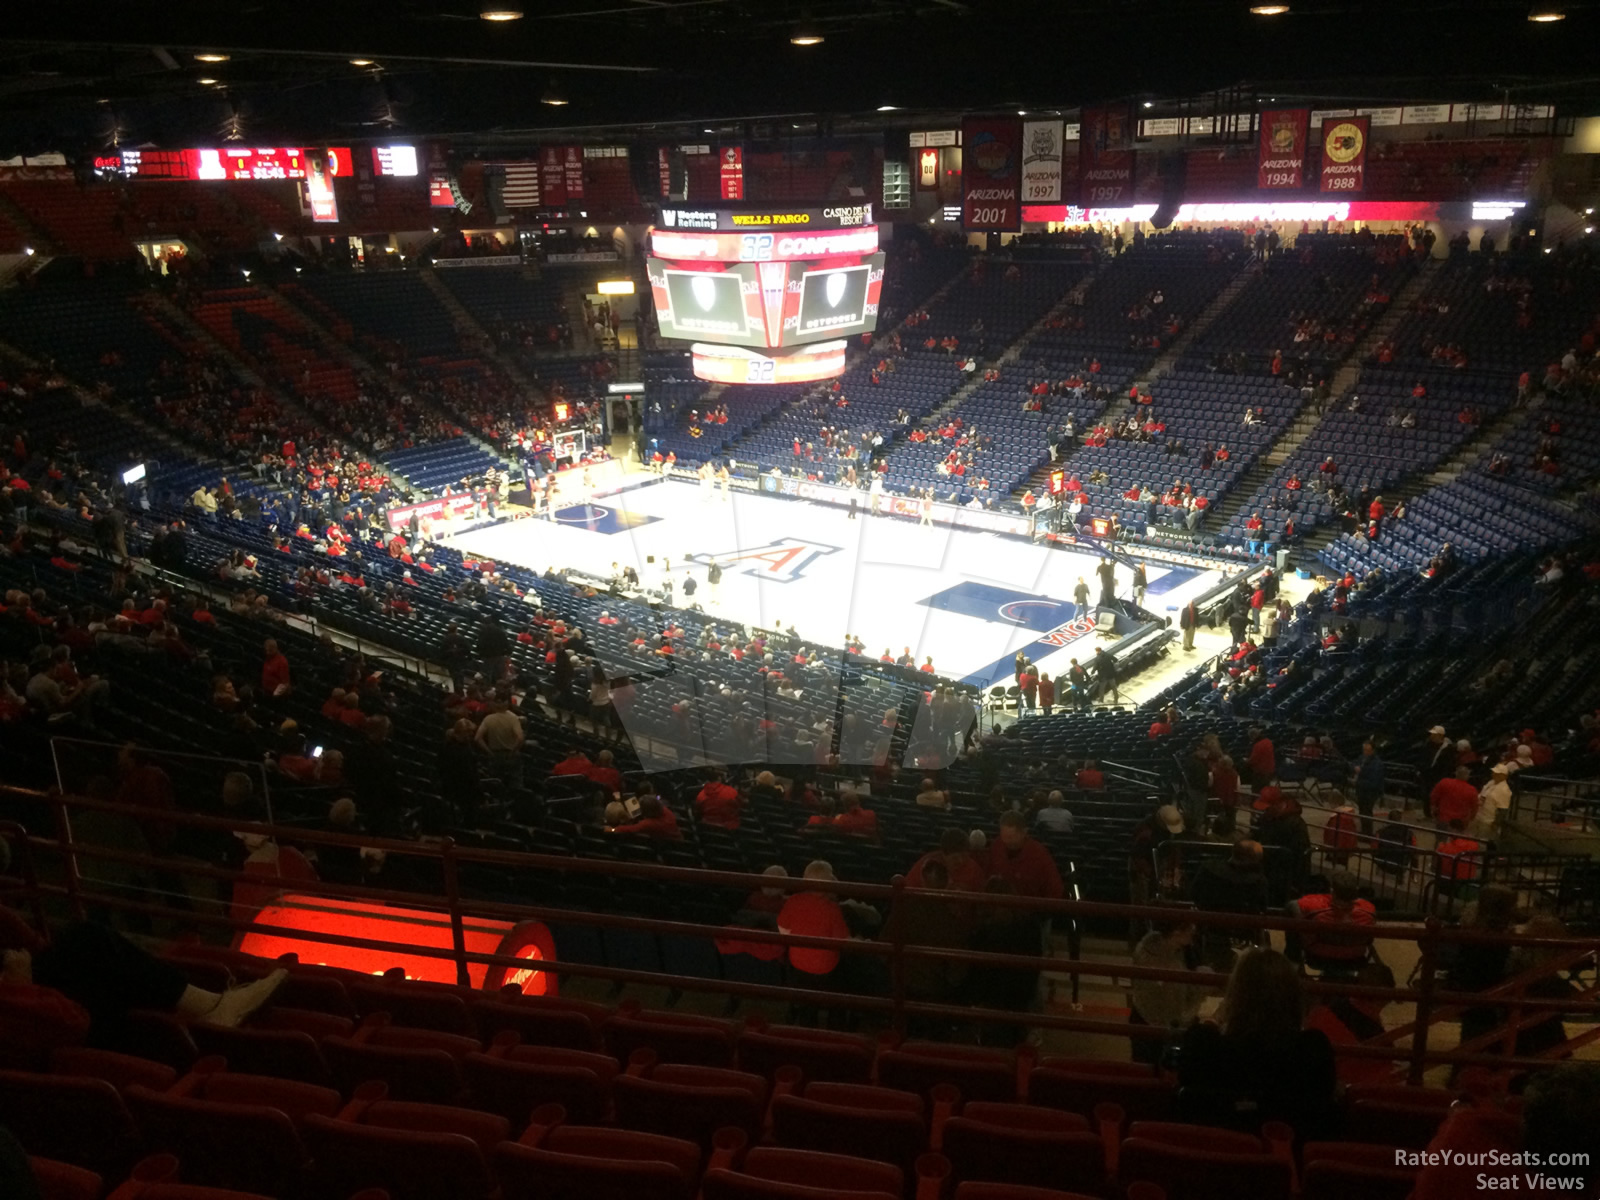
[0,786,1600,1082]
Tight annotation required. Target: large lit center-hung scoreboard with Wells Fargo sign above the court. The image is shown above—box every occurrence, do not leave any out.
[646,205,883,382]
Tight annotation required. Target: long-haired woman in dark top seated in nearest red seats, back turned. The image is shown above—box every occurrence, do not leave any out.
[1178,947,1336,1139]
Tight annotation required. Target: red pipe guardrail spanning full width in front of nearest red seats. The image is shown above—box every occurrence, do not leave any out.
[0,786,1600,1083]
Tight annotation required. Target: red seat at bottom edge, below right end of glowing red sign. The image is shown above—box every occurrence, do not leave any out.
[494,1125,701,1200]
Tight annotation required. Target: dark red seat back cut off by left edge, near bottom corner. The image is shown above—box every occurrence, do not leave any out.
[0,1070,139,1179]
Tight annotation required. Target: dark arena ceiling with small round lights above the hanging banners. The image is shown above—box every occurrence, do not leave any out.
[0,0,1600,157]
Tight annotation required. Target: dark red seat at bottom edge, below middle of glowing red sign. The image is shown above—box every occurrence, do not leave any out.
[304,1117,496,1200]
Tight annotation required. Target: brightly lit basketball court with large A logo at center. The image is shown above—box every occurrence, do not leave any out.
[451,482,1221,688]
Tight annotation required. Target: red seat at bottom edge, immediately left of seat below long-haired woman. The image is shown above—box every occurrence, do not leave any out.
[941,1104,1106,1192]
